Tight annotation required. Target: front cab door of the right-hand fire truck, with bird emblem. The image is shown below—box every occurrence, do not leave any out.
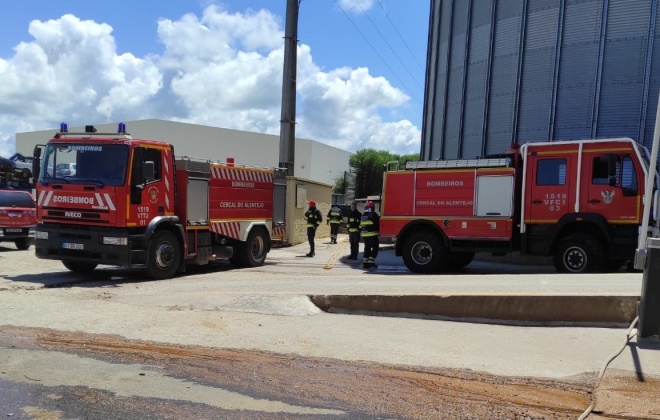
[580,153,641,223]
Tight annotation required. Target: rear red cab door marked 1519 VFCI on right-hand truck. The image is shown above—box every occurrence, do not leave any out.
[525,149,576,224]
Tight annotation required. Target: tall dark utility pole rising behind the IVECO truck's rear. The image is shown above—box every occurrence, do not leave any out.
[280,0,300,176]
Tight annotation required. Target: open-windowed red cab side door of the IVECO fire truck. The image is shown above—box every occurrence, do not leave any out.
[127,147,174,226]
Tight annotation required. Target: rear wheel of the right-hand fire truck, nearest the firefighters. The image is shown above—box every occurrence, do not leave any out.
[403,232,445,274]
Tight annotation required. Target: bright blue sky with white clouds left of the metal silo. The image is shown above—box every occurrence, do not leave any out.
[0,0,429,156]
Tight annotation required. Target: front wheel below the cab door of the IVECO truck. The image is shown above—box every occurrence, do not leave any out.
[146,230,181,280]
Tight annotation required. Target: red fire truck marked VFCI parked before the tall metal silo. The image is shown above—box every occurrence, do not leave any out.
[381,139,658,273]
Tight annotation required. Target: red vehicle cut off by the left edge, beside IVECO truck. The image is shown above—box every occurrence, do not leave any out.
[0,190,37,250]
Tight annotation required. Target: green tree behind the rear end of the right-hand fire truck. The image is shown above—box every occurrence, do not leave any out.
[348,148,419,197]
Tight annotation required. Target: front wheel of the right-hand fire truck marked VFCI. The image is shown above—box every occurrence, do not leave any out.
[553,234,605,273]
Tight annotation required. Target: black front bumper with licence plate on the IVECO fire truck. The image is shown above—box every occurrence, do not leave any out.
[34,224,131,267]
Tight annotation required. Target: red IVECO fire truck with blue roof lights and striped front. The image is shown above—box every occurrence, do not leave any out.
[34,123,286,279]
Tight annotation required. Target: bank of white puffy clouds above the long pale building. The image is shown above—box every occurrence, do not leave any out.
[0,5,420,155]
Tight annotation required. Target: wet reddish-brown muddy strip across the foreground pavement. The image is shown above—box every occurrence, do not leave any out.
[0,327,604,419]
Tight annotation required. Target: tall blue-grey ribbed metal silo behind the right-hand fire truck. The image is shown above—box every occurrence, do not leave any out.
[421,0,660,160]
